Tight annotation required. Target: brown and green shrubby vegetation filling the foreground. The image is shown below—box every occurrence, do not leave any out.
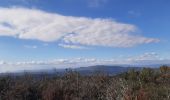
[0,66,170,100]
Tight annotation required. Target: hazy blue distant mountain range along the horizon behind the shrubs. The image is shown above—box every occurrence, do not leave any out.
[0,64,167,75]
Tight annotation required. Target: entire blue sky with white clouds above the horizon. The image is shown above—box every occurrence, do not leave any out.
[0,0,170,72]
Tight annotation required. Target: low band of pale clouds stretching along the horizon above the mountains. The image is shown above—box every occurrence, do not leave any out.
[0,52,170,73]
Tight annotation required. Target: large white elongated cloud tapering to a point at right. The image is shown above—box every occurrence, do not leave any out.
[0,7,159,48]
